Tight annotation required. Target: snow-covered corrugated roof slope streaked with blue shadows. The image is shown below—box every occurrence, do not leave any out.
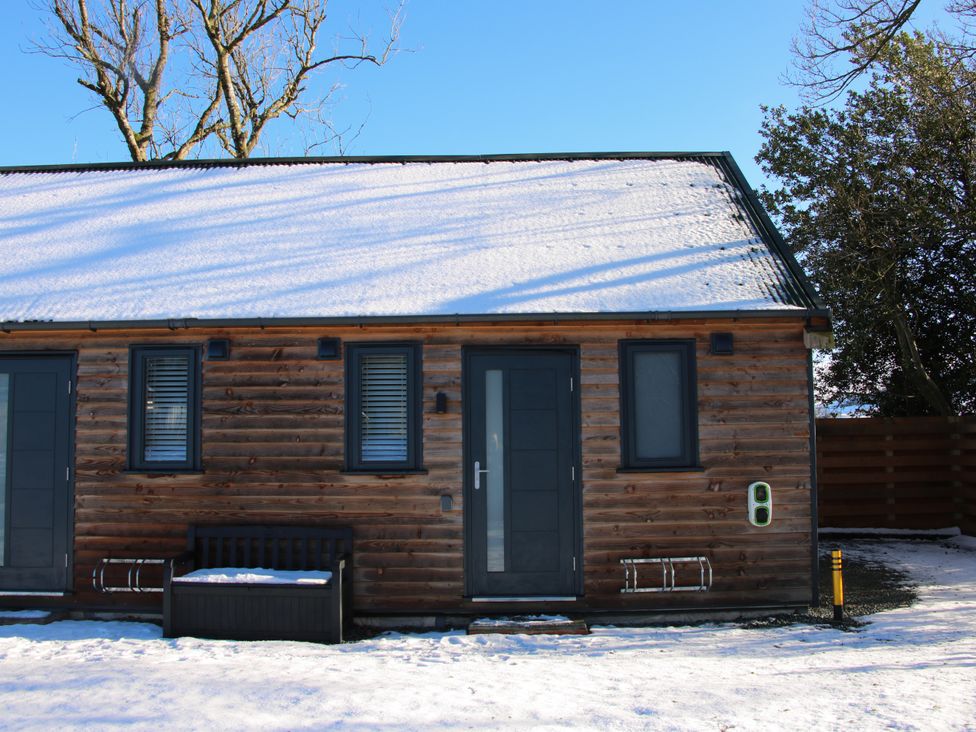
[0,156,804,321]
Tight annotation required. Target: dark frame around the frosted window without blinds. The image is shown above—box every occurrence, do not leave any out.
[618,339,701,471]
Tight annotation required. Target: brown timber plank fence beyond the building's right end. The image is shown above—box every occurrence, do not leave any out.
[817,416,976,535]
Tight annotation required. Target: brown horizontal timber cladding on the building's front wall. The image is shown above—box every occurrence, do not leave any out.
[0,318,816,613]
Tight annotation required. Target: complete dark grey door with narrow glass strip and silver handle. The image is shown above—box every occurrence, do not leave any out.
[464,351,579,597]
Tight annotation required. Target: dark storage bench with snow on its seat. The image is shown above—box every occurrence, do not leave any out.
[163,525,352,643]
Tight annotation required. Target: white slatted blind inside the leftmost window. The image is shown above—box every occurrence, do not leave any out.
[143,356,190,462]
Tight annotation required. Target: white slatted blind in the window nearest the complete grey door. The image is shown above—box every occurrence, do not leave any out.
[359,354,408,463]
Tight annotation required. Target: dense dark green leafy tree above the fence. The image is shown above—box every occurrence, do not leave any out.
[756,34,976,416]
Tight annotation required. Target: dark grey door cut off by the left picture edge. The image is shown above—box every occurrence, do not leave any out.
[0,357,72,592]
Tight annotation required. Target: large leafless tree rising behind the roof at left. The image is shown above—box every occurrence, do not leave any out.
[36,0,403,161]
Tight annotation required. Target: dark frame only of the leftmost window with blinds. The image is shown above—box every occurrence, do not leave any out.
[128,345,203,473]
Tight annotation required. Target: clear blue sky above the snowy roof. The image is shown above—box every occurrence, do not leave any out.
[0,0,952,186]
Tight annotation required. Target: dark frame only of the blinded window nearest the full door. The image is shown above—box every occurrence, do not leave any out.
[343,342,423,473]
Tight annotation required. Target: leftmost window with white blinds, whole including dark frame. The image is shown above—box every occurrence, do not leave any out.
[129,346,200,470]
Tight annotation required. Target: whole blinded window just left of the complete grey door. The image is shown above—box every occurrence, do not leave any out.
[346,344,420,470]
